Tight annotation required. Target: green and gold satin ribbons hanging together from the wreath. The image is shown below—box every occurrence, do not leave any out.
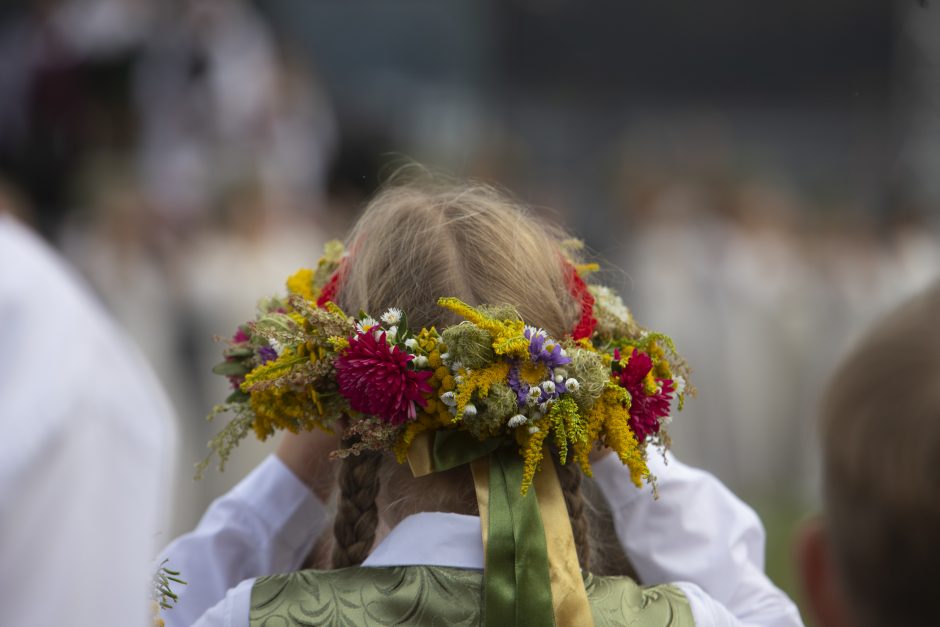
[408,431,593,627]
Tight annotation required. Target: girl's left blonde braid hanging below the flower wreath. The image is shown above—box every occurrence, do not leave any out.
[333,451,382,568]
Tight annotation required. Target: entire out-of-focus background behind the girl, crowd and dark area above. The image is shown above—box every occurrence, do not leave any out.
[0,0,940,620]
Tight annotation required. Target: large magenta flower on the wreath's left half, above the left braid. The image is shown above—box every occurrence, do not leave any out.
[336,330,434,425]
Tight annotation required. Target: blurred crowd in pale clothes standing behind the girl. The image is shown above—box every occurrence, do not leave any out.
[0,0,940,538]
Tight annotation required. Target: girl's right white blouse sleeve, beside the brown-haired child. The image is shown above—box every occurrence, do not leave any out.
[594,450,803,627]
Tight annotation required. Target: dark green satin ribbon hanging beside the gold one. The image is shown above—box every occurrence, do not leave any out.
[433,431,555,627]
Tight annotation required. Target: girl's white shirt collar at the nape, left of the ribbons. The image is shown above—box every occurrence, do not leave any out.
[362,512,483,570]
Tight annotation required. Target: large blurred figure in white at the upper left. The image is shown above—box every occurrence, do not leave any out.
[133,0,336,229]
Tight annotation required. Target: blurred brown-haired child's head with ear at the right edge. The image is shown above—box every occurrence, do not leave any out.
[800,284,940,627]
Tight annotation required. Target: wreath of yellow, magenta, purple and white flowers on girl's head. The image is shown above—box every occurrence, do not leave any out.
[200,242,690,494]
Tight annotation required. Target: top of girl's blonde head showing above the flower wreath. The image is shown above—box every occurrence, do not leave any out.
[338,182,579,337]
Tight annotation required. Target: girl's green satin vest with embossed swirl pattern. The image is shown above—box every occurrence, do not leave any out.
[250,566,694,627]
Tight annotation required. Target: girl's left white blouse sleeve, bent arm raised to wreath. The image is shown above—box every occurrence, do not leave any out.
[161,455,328,627]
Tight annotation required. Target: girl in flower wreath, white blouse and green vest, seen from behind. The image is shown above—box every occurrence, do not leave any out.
[158,184,801,627]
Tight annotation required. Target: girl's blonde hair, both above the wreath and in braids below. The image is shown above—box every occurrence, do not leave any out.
[333,180,589,568]
